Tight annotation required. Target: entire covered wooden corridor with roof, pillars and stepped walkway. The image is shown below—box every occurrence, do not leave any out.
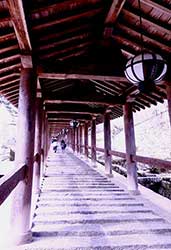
[0,0,171,250]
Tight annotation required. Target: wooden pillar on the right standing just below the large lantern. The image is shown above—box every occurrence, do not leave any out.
[123,103,138,194]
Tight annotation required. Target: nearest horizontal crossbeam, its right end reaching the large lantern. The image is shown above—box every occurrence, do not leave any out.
[38,72,128,82]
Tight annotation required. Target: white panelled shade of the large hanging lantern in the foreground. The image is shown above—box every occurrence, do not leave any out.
[125,52,167,86]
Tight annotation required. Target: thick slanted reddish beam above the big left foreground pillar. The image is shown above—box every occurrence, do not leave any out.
[7,0,32,53]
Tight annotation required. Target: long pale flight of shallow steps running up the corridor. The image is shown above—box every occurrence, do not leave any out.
[7,152,171,250]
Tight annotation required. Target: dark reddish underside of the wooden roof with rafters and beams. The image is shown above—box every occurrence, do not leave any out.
[0,0,171,134]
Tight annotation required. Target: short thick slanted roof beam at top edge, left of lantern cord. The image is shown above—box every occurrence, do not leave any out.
[105,0,126,24]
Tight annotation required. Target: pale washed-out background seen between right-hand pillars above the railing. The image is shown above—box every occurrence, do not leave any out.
[95,101,171,160]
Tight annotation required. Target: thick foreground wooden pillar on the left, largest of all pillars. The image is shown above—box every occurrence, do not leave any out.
[9,68,36,244]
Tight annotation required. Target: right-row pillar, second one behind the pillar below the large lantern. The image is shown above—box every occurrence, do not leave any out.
[91,117,96,167]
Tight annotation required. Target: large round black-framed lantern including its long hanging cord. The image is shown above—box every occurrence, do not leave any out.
[124,0,167,92]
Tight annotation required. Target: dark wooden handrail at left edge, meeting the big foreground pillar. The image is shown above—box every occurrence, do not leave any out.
[0,165,27,205]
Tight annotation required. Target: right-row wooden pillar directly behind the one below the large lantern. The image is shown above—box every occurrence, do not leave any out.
[104,112,112,177]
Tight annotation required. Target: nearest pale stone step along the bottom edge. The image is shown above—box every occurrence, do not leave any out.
[9,234,171,250]
